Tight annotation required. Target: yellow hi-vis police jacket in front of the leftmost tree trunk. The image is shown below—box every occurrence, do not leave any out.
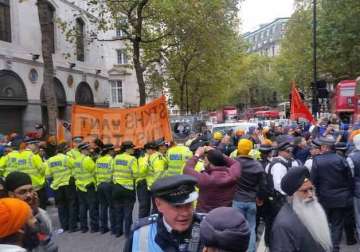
[45,153,74,190]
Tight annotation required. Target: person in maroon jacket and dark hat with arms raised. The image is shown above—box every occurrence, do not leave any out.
[184,147,241,213]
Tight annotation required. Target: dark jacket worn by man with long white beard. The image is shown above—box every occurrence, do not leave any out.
[270,203,325,252]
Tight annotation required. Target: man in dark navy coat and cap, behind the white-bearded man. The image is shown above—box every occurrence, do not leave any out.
[311,137,353,252]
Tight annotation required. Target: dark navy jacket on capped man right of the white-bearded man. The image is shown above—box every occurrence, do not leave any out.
[311,152,353,208]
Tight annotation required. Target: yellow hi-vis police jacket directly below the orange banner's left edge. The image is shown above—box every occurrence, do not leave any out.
[74,154,95,192]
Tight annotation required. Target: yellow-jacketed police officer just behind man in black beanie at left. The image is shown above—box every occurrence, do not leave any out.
[17,138,47,209]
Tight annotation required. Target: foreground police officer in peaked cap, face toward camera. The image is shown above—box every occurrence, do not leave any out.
[124,175,202,252]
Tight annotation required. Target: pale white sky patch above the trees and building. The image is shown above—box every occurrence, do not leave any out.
[240,0,294,33]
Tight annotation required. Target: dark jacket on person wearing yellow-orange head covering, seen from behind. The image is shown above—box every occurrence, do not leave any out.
[234,156,266,202]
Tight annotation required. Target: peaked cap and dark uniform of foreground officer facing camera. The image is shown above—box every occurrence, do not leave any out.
[124,175,204,252]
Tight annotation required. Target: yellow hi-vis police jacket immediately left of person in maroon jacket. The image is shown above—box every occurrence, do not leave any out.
[165,145,193,176]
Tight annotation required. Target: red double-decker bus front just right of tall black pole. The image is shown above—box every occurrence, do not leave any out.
[331,80,360,123]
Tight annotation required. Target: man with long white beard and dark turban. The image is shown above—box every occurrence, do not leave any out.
[270,167,332,252]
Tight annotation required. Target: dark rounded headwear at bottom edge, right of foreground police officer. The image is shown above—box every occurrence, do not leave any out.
[200,207,250,252]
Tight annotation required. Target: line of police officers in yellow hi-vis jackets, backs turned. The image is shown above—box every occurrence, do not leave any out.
[0,137,192,237]
